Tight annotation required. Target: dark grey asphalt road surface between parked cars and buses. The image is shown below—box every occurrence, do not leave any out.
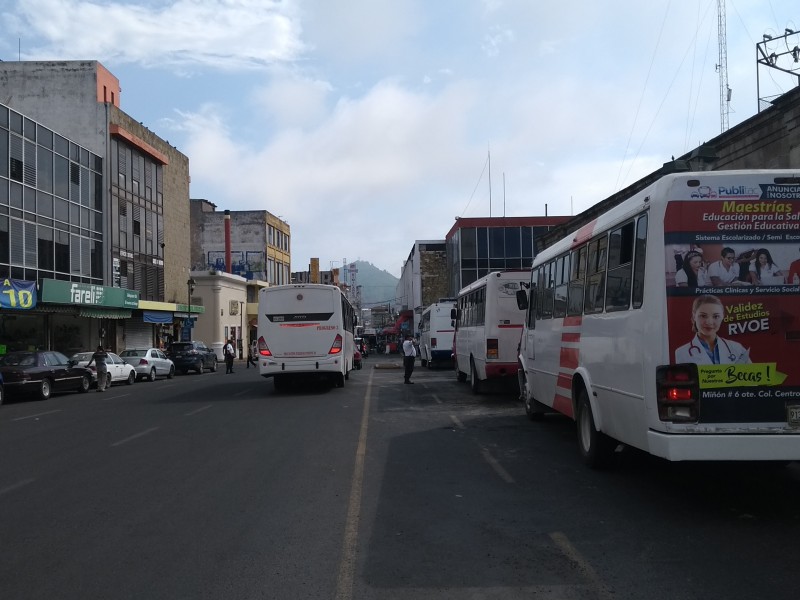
[0,355,800,600]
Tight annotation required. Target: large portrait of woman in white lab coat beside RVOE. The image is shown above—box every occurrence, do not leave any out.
[675,294,751,365]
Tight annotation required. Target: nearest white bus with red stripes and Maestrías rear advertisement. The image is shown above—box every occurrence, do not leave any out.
[518,171,800,467]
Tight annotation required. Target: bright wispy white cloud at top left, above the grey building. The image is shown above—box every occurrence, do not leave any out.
[8,0,304,70]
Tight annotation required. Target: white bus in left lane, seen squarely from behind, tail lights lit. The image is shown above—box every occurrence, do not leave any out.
[258,284,356,390]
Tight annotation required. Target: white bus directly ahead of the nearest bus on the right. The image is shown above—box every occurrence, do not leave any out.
[453,271,530,393]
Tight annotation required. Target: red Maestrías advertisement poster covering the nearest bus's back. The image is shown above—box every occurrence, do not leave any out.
[664,182,800,416]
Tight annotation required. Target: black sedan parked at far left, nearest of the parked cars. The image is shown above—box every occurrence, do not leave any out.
[0,350,92,400]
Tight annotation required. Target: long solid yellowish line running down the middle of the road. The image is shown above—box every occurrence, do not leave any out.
[336,370,375,600]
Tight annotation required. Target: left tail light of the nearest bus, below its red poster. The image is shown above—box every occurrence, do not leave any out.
[656,364,700,423]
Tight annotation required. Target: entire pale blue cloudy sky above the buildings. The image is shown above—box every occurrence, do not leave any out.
[0,0,800,276]
